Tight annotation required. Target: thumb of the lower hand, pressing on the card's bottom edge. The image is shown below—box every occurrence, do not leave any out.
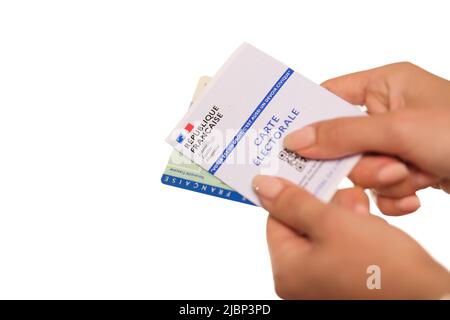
[253,175,325,237]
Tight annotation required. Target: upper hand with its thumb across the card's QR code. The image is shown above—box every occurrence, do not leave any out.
[285,63,450,215]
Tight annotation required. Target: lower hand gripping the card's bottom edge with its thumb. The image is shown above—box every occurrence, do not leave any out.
[253,176,450,299]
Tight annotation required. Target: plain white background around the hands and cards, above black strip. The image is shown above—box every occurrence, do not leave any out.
[0,0,450,298]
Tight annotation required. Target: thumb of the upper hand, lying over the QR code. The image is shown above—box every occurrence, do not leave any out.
[284,113,404,159]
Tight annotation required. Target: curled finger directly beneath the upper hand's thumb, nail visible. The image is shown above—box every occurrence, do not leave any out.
[348,155,411,188]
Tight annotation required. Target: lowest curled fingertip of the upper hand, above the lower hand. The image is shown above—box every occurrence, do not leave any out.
[372,191,420,216]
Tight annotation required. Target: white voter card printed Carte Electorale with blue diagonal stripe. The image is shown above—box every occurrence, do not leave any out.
[167,44,364,205]
